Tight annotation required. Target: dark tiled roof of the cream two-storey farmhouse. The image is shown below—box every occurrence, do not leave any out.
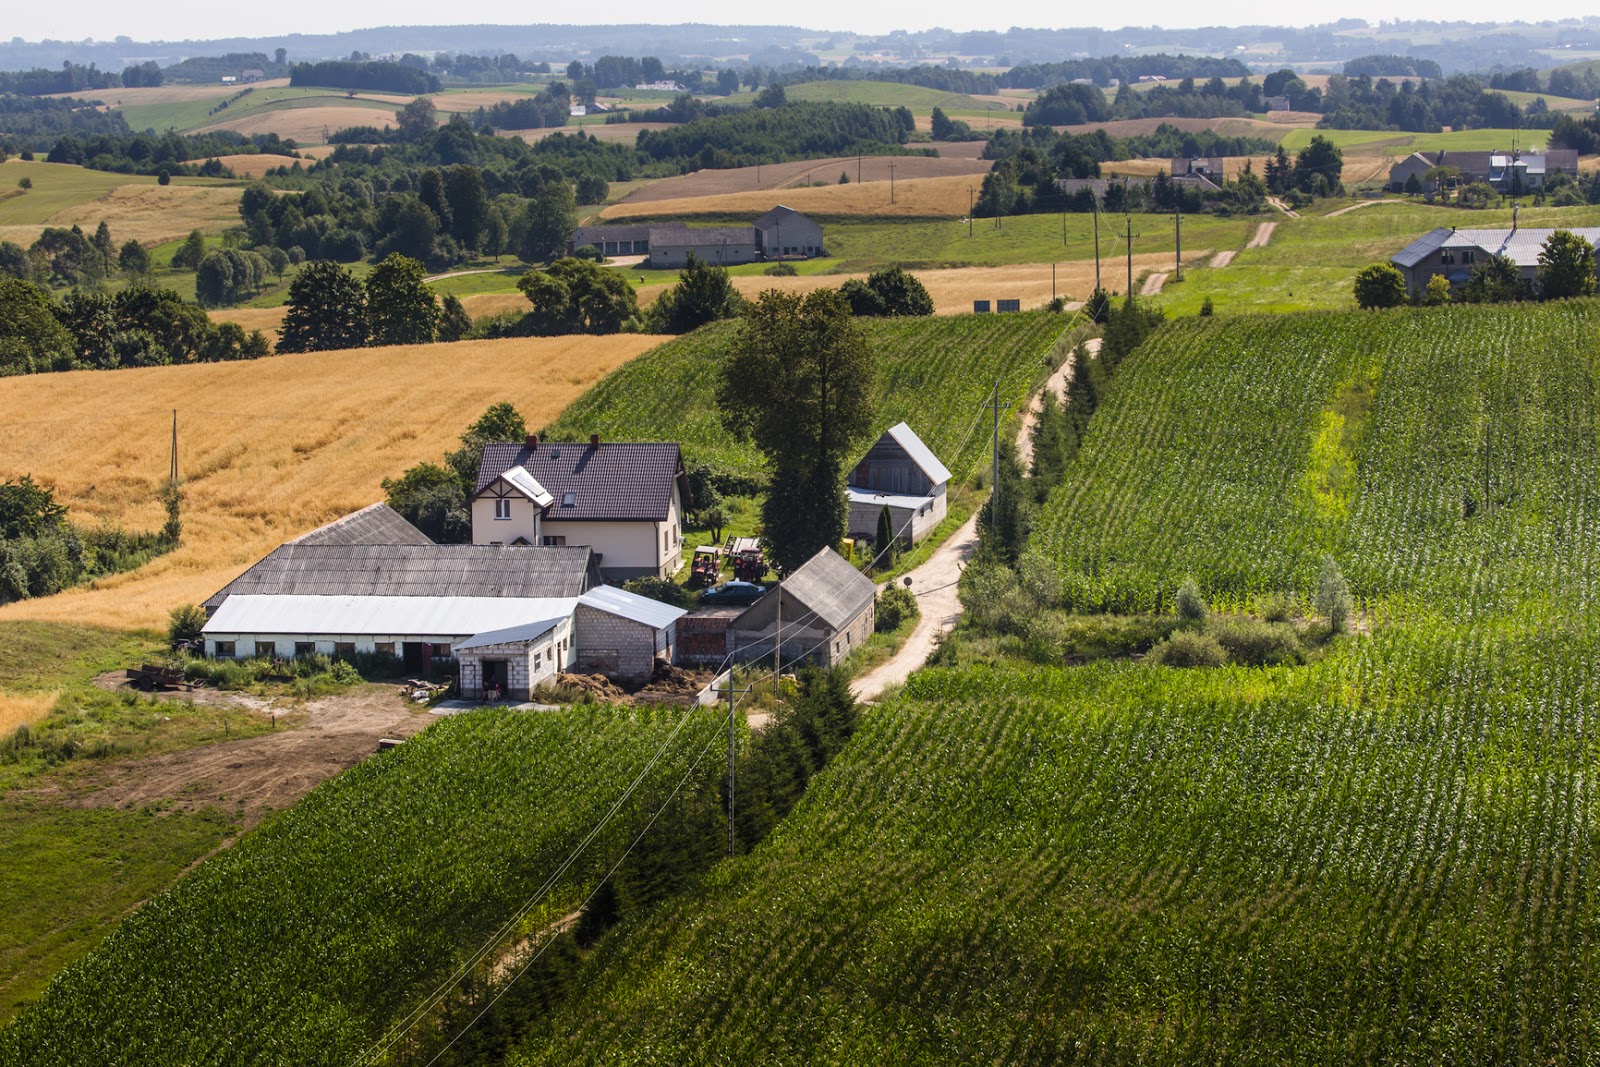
[477,442,683,523]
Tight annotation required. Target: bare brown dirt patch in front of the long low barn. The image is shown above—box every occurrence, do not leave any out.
[27,685,432,827]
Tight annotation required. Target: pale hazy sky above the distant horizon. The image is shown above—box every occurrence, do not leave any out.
[18,0,1592,42]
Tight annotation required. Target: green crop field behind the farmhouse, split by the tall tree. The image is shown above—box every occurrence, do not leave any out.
[544,312,1067,478]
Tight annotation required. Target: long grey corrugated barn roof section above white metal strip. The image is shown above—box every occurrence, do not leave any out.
[205,542,595,609]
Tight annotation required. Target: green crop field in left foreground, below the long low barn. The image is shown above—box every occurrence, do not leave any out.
[0,707,723,1065]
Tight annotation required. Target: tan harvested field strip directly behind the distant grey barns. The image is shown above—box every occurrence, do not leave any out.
[600,174,987,219]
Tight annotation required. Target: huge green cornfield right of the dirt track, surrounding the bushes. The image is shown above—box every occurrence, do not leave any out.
[512,295,1600,1064]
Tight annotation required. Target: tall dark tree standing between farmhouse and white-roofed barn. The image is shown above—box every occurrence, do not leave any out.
[717,290,874,571]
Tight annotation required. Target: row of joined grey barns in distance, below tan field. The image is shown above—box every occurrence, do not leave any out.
[566,205,824,270]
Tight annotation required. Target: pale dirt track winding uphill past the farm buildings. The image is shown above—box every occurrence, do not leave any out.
[850,338,1101,701]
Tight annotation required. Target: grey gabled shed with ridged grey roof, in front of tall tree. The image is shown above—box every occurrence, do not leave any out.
[728,549,877,667]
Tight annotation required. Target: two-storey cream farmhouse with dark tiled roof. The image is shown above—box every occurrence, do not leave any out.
[472,435,688,581]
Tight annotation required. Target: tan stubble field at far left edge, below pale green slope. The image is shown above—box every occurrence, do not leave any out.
[0,184,242,245]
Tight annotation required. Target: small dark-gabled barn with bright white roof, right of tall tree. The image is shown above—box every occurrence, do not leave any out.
[845,422,950,547]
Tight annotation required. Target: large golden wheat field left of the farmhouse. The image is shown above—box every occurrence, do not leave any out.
[0,334,662,629]
